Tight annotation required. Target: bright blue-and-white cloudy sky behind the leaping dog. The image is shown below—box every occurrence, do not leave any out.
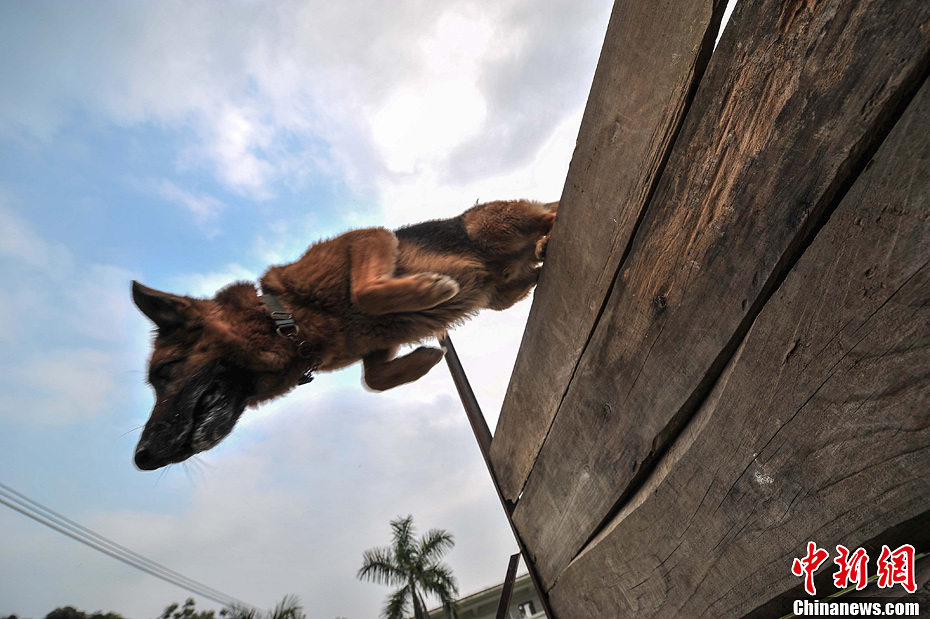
[0,0,611,619]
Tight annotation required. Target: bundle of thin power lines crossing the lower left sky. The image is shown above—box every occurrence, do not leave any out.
[0,483,255,608]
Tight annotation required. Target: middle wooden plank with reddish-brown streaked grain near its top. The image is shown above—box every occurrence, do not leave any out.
[514,0,930,586]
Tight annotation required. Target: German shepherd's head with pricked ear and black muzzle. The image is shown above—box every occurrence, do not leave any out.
[132,282,299,471]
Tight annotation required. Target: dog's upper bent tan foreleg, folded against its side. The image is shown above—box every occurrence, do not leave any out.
[349,228,459,315]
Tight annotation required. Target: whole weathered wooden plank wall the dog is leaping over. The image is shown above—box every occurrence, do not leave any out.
[491,0,930,617]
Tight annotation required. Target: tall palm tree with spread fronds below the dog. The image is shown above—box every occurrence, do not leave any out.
[358,516,459,619]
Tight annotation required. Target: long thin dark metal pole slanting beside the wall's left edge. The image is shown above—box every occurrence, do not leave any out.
[439,334,555,619]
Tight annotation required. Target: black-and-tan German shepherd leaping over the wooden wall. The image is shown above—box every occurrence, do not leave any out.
[132,200,558,470]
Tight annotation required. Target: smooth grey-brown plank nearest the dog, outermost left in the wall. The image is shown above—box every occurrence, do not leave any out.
[491,0,724,501]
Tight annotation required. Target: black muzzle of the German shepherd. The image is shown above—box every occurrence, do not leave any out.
[133,368,253,471]
